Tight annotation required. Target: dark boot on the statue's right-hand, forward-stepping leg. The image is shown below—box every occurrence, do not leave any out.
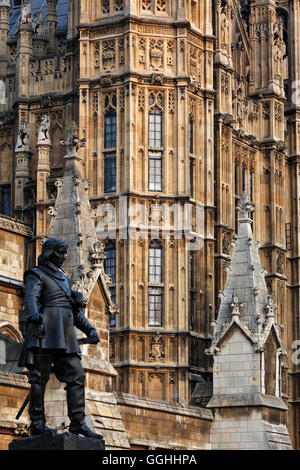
[66,385,103,439]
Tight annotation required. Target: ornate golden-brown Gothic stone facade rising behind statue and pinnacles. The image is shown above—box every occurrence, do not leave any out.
[0,0,300,448]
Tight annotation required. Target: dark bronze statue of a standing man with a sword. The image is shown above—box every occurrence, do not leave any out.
[19,238,103,439]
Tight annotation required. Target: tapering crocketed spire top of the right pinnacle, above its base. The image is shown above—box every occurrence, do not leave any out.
[209,192,278,353]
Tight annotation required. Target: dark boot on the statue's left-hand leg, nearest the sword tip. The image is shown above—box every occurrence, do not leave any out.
[29,383,56,436]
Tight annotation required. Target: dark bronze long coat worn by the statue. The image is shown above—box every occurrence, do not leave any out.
[19,262,94,366]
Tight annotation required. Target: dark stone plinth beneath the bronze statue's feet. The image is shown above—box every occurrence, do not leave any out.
[9,432,105,451]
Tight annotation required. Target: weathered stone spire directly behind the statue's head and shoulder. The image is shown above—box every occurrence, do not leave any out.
[48,122,116,313]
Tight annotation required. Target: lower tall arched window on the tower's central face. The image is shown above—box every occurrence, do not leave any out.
[148,241,163,326]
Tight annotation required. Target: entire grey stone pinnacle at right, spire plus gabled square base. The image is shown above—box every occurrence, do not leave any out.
[206,193,291,450]
